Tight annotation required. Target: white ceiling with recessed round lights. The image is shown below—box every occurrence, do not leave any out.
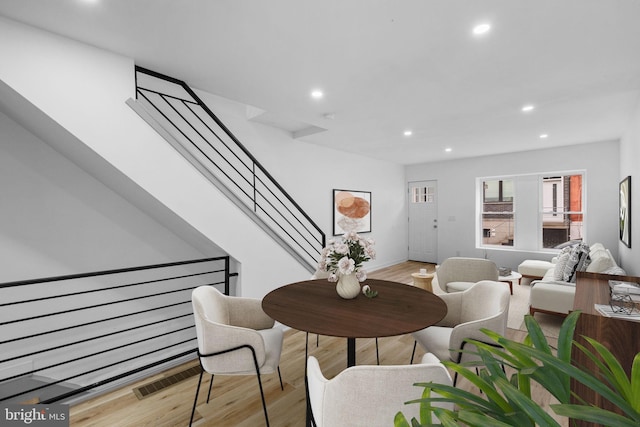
[0,0,640,164]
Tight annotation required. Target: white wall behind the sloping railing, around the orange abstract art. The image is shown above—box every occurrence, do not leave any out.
[197,91,407,271]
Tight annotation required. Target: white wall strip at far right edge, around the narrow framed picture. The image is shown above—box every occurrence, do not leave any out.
[618,100,640,276]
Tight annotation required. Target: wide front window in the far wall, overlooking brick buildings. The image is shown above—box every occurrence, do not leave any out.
[476,172,585,251]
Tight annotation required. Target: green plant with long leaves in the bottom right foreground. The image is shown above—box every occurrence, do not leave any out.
[394,311,640,427]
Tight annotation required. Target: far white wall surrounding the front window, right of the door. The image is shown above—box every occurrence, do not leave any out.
[406,141,619,269]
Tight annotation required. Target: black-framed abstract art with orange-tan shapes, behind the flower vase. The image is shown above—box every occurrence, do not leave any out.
[333,190,371,236]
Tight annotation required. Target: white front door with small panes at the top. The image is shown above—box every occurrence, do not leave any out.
[409,181,438,264]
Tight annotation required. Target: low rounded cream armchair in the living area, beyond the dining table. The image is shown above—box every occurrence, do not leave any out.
[436,257,499,292]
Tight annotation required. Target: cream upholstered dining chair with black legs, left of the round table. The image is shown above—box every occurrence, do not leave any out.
[189,286,284,426]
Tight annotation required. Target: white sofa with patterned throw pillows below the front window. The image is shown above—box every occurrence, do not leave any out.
[518,243,625,316]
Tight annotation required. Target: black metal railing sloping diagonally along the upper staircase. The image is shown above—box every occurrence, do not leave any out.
[134,67,325,271]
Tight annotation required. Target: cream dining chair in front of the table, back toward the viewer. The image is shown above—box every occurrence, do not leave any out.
[307,353,453,427]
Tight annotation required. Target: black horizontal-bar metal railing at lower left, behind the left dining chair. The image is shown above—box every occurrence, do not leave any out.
[0,256,237,404]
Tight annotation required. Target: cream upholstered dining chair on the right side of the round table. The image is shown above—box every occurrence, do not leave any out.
[411,280,510,385]
